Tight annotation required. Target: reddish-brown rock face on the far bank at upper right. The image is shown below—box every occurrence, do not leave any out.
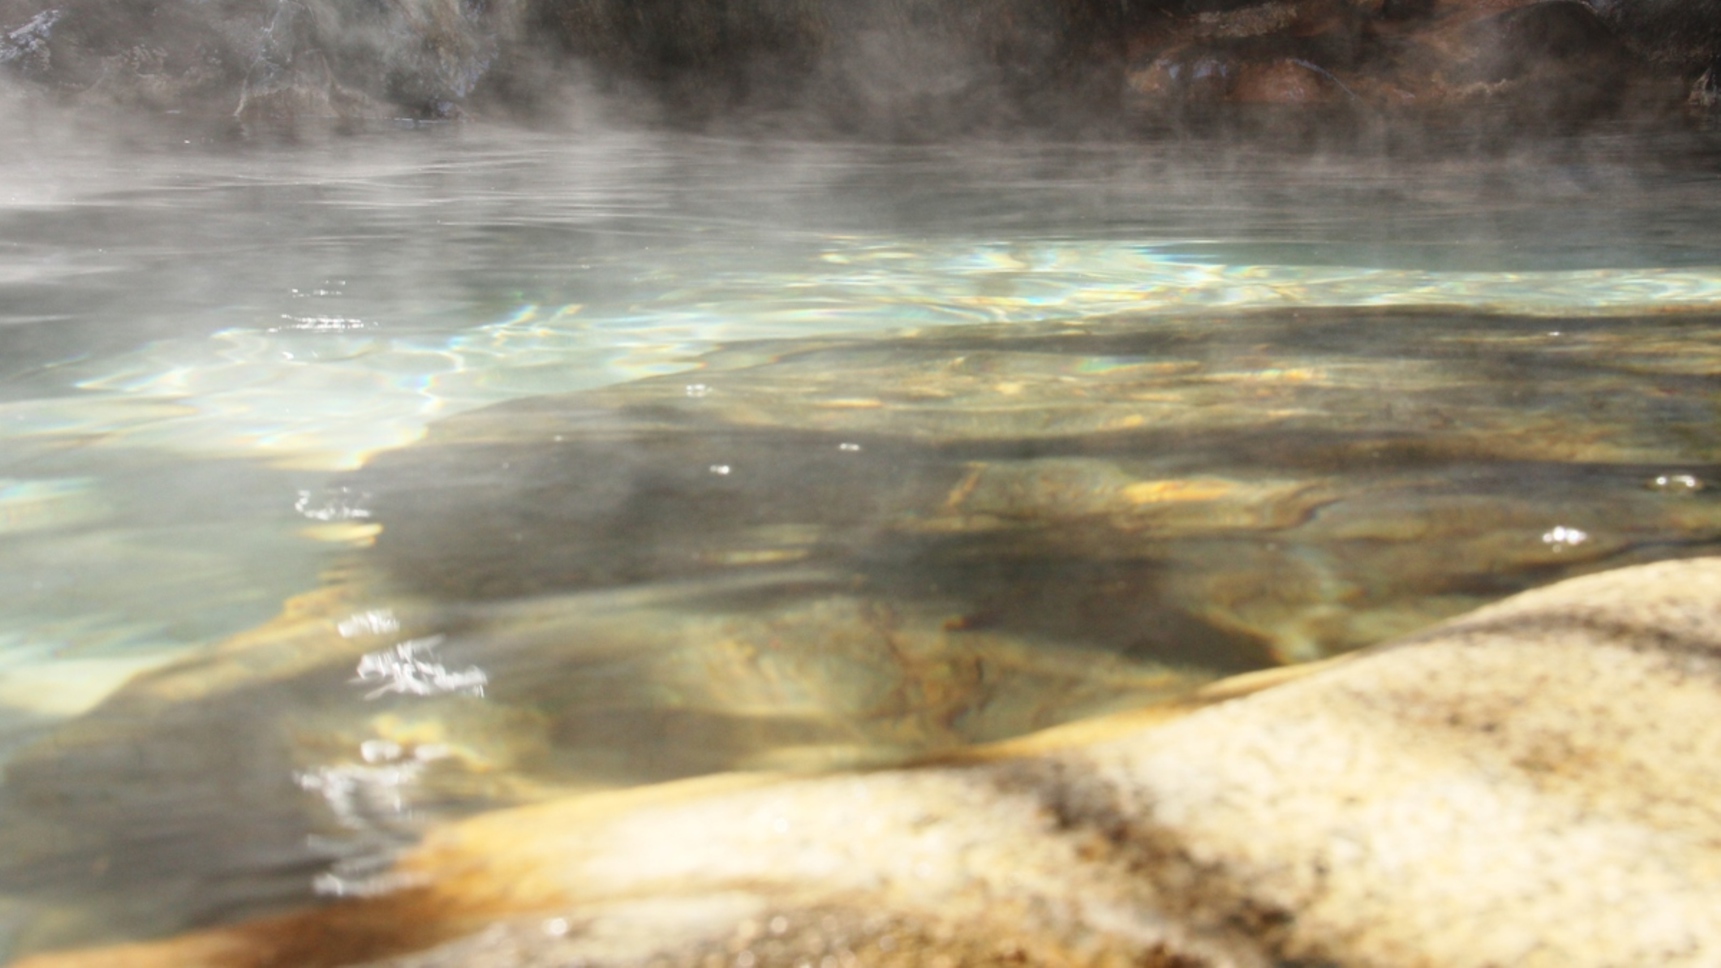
[1127,0,1695,126]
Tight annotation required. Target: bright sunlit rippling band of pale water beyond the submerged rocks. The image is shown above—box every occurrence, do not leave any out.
[23,239,1721,470]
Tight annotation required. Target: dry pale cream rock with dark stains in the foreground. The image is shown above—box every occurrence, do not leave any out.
[21,558,1721,968]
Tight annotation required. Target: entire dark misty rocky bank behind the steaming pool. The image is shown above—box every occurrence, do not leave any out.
[0,0,1721,124]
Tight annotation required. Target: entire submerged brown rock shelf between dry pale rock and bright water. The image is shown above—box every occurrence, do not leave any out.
[0,308,1721,946]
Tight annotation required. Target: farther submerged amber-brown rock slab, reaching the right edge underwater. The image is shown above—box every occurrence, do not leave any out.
[348,310,1721,670]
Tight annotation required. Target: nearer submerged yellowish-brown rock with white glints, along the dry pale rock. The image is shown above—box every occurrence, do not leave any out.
[0,574,1215,947]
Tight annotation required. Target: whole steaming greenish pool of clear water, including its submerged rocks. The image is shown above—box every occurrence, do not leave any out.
[0,119,1721,951]
